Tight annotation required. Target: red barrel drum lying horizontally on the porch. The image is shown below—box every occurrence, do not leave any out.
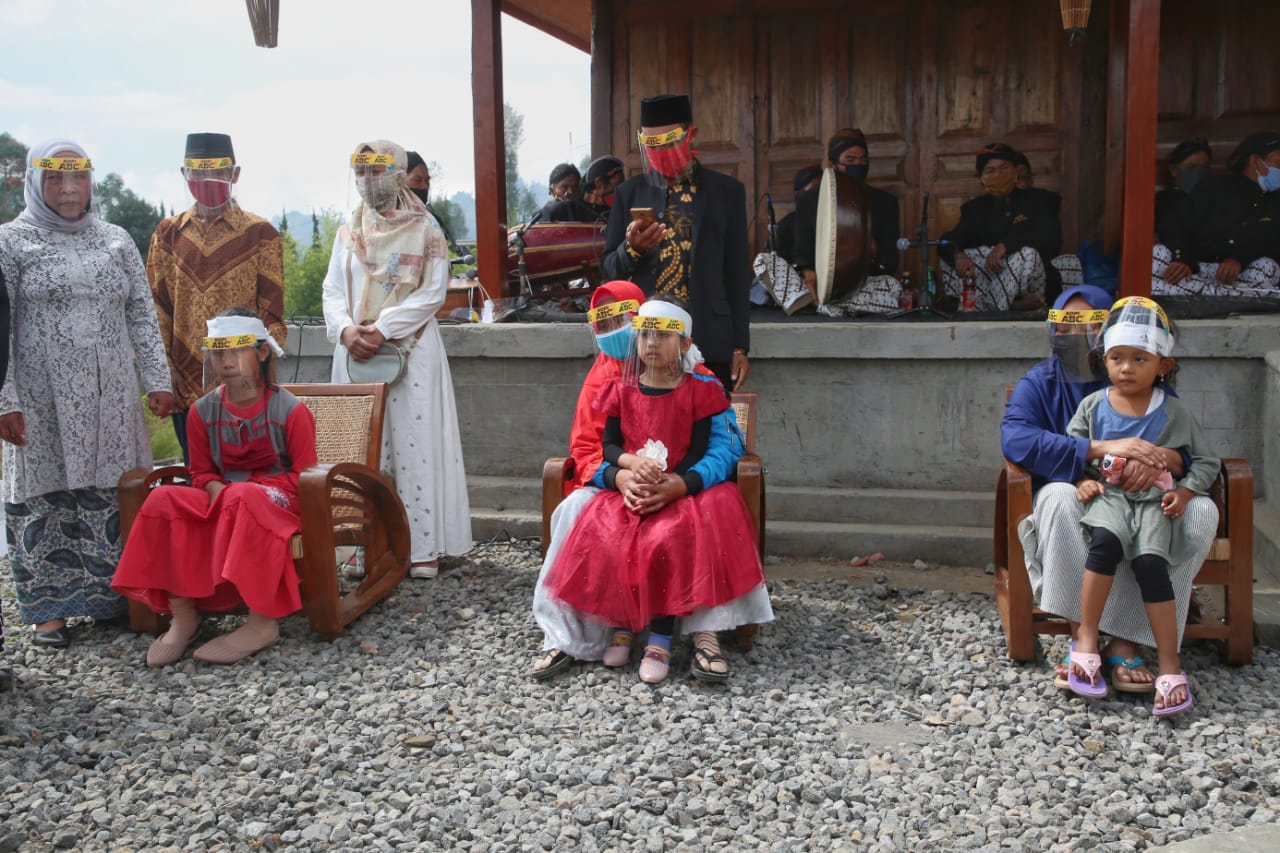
[507,222,604,297]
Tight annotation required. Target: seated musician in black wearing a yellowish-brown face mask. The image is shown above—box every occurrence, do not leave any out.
[938,142,1062,311]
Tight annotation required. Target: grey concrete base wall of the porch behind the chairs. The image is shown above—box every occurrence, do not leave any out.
[288,316,1280,494]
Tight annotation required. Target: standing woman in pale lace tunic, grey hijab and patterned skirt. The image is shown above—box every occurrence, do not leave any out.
[0,140,173,647]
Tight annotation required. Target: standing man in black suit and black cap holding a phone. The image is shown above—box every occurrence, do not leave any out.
[600,95,751,389]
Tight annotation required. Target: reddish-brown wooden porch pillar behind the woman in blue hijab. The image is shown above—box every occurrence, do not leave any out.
[1119,0,1160,296]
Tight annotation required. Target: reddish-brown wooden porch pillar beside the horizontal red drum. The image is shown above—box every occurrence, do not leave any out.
[471,0,508,298]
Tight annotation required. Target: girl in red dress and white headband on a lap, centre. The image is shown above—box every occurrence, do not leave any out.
[548,300,764,684]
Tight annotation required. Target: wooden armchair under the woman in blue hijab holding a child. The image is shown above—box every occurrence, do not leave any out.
[992,388,1253,666]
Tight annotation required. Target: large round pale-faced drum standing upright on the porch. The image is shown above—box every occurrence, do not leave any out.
[814,163,872,305]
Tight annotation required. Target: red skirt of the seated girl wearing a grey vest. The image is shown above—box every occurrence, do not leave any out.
[111,483,302,619]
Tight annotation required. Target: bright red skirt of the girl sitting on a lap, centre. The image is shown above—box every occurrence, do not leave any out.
[548,483,764,630]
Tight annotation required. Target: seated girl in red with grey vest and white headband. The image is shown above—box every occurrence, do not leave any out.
[111,309,316,666]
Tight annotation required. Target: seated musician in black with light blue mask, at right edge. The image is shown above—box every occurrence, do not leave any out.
[1151,131,1280,297]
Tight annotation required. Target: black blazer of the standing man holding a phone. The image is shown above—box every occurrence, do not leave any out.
[600,167,751,364]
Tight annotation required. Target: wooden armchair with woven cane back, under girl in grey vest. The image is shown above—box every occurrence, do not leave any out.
[118,383,410,640]
